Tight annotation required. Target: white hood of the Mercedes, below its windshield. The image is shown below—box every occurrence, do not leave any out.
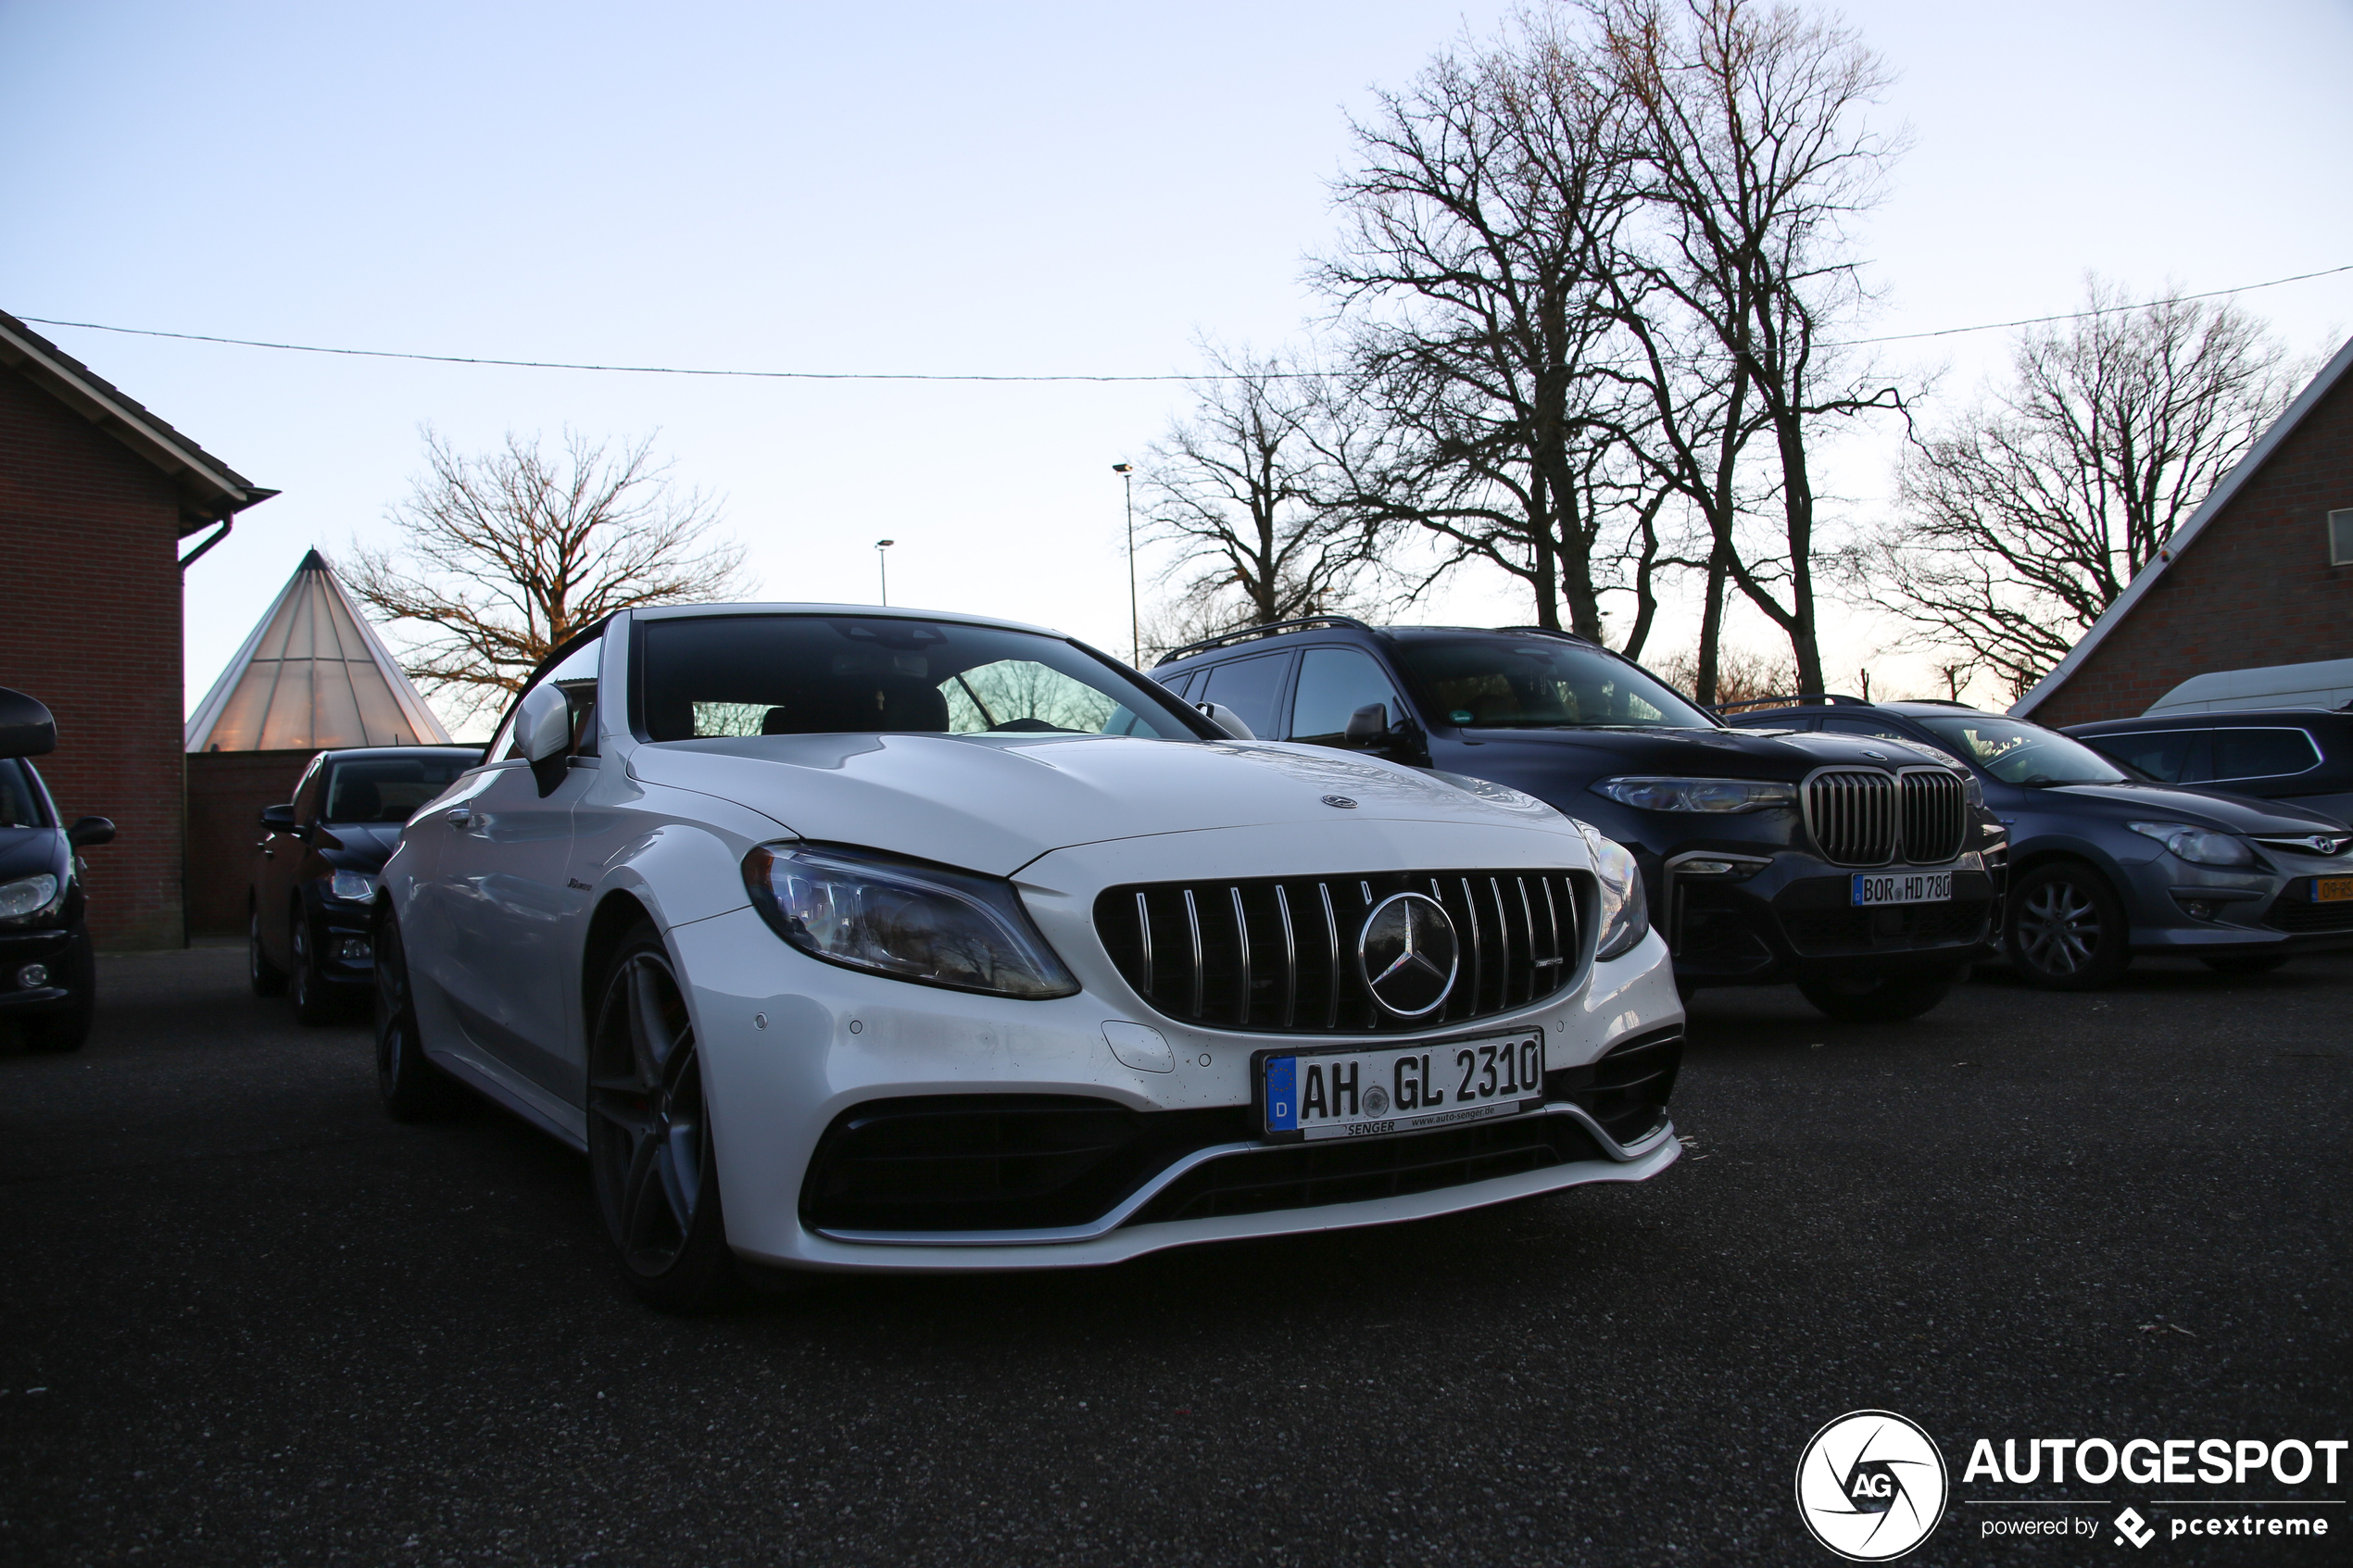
[628,735,1569,877]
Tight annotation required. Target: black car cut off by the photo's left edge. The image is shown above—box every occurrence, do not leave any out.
[0,686,115,1051]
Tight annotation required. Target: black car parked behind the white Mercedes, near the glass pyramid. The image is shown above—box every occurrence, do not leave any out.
[247,746,483,1022]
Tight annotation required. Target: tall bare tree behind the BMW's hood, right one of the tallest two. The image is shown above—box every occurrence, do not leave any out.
[1586,0,1896,696]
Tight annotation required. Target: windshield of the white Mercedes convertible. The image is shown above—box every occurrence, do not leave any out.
[637,616,1200,741]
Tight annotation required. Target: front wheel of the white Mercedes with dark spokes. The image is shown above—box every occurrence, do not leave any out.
[588,926,739,1311]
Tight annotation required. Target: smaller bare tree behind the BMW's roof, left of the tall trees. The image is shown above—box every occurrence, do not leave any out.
[1143,348,1377,637]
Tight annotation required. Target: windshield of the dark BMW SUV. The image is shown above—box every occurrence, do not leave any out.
[1398,634,1718,729]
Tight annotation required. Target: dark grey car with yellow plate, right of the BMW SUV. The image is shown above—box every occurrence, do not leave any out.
[1731,696,2353,990]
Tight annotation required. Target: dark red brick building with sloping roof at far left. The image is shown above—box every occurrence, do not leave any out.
[0,313,278,947]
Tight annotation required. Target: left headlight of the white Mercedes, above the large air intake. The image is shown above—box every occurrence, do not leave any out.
[744,844,1077,999]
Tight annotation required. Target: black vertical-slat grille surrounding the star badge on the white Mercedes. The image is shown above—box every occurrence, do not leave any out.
[1094,870,1593,1035]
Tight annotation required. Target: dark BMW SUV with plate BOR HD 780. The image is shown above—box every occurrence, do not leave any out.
[1153,616,2003,1018]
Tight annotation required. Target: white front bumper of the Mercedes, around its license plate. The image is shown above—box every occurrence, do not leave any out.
[671,888,1682,1274]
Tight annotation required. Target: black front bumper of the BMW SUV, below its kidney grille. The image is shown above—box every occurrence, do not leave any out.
[1652,848,2000,985]
